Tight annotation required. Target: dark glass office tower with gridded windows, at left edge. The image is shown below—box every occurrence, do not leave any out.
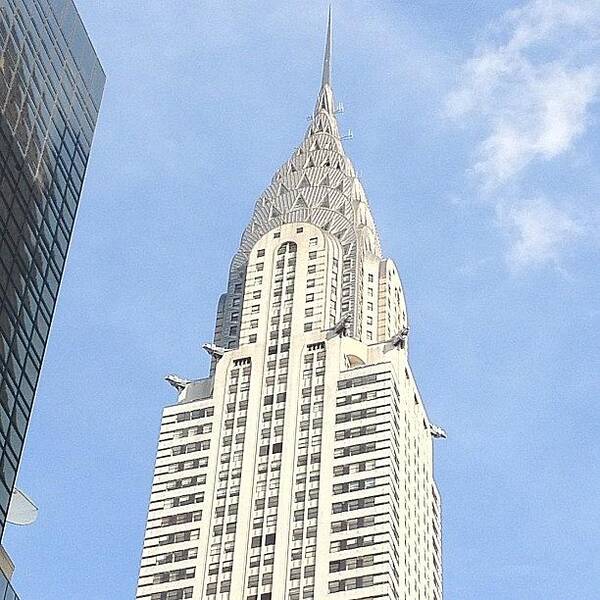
[0,0,105,548]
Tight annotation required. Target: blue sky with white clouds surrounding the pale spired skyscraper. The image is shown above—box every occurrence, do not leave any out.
[5,0,600,600]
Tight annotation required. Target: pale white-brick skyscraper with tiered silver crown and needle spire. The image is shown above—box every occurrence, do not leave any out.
[136,14,443,600]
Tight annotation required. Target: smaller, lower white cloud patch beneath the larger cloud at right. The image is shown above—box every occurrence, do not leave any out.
[498,198,583,269]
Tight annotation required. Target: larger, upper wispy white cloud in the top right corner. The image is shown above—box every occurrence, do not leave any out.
[446,0,600,189]
